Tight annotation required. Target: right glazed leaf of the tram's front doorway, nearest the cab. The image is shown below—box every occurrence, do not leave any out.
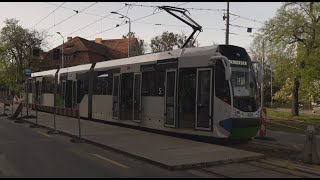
[195,68,212,130]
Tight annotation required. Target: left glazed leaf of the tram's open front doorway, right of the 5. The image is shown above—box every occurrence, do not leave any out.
[165,70,177,127]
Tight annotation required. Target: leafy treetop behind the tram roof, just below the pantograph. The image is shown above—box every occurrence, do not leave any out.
[150,31,199,52]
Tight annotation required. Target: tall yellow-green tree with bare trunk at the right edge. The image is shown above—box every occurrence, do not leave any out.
[262,2,320,115]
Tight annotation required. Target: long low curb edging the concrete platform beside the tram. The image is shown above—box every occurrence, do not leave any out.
[21,120,266,171]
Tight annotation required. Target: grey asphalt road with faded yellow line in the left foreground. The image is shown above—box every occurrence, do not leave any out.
[0,117,198,178]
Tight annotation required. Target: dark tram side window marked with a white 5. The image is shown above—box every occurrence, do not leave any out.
[141,71,165,96]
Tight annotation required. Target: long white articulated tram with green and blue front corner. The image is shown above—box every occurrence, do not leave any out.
[27,45,261,139]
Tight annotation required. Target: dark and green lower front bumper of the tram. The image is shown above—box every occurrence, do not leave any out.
[219,118,261,139]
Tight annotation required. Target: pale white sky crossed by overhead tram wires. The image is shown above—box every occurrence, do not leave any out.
[0,2,282,50]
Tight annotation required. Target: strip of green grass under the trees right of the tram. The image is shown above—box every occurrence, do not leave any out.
[267,108,320,123]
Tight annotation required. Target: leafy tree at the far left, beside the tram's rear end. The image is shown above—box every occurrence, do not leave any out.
[0,19,46,95]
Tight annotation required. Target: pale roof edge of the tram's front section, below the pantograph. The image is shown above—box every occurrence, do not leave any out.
[94,46,217,70]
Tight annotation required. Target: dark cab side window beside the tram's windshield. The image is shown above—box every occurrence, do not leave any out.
[215,61,231,104]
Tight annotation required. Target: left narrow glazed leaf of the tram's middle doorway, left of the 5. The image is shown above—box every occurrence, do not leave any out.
[112,74,120,119]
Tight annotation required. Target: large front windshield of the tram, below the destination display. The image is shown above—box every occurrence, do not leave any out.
[231,65,259,112]
